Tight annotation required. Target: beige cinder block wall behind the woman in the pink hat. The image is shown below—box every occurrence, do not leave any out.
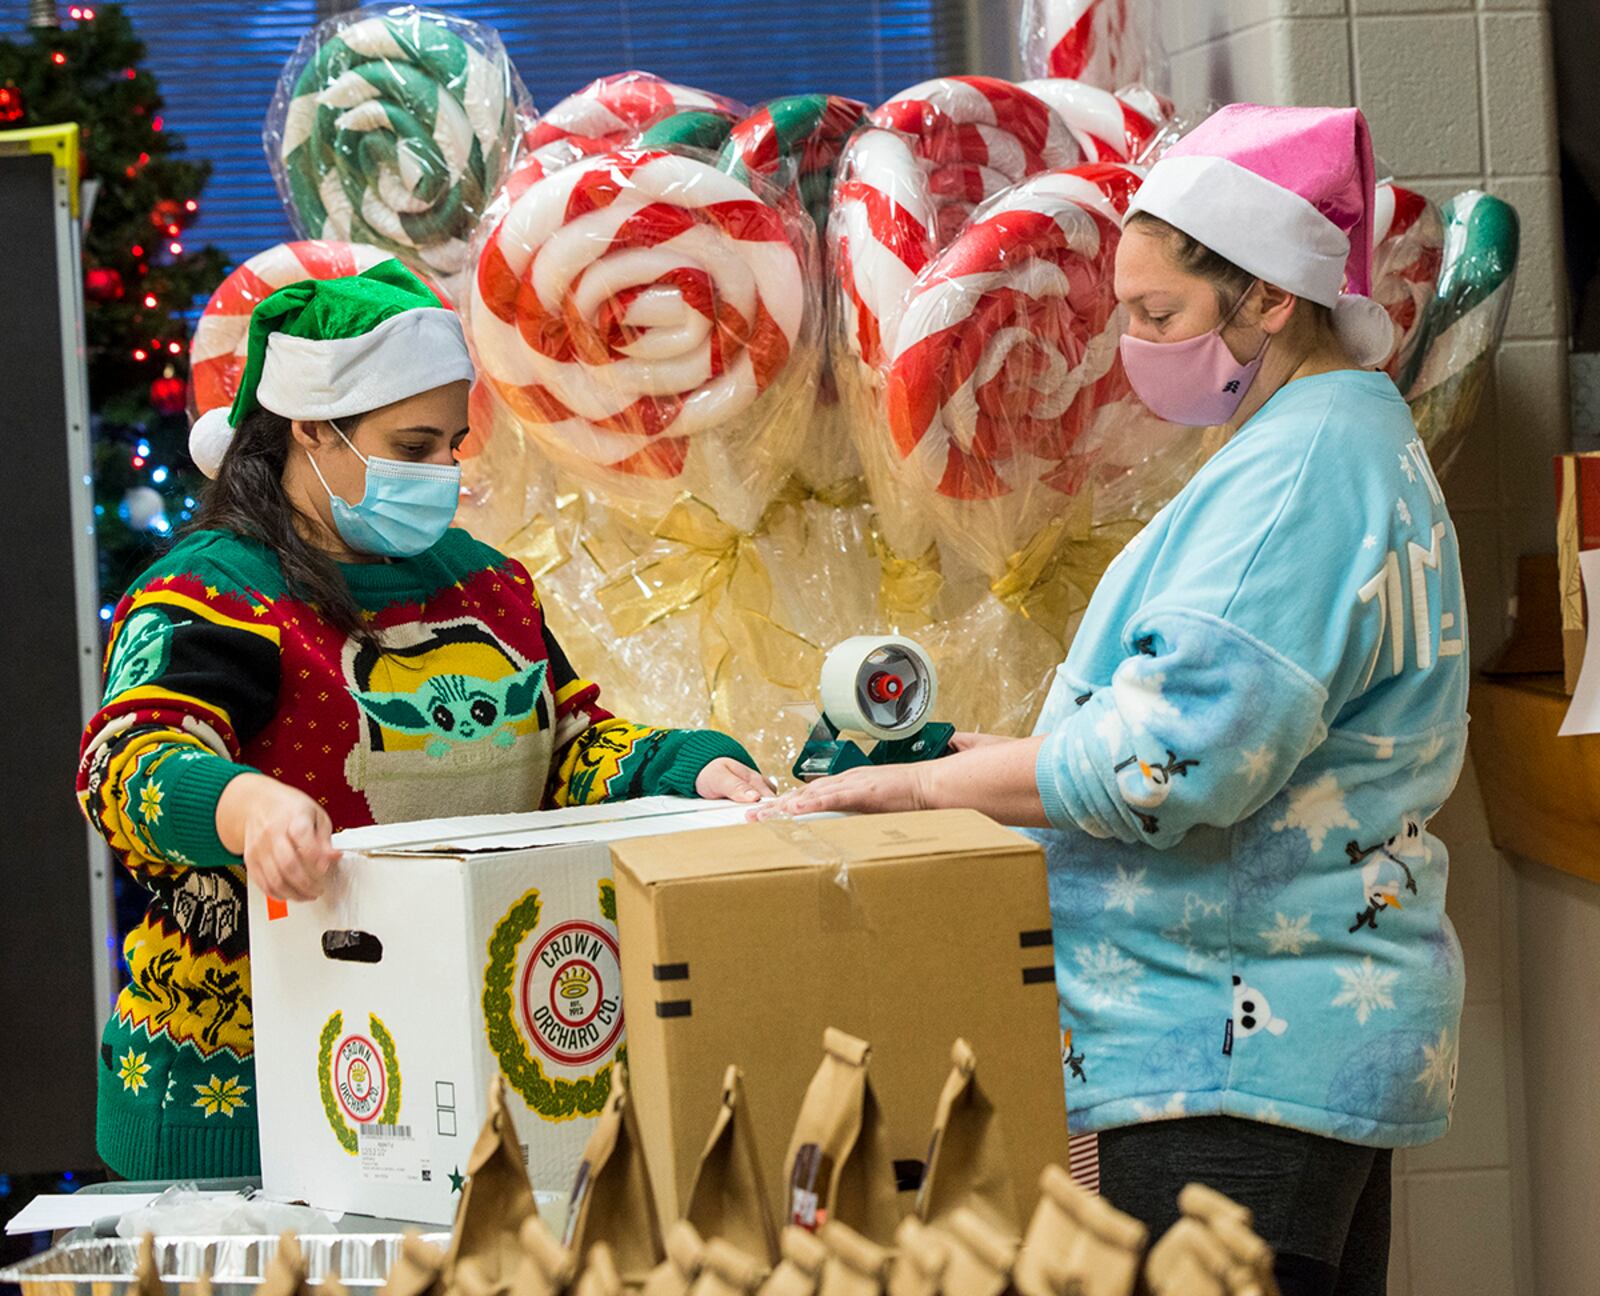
[971,0,1574,1296]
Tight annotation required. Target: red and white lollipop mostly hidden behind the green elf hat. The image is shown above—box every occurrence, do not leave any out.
[189,238,392,416]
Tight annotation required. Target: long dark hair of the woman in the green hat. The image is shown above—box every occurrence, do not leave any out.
[194,406,374,645]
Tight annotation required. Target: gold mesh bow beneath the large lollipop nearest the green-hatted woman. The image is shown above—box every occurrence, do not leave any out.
[598,494,821,718]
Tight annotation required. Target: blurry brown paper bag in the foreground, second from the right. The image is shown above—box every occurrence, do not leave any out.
[1011,1165,1149,1296]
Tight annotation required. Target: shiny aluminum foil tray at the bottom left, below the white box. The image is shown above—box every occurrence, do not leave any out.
[0,1232,450,1296]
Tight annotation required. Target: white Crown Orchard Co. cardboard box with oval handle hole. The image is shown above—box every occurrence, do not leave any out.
[250,797,744,1224]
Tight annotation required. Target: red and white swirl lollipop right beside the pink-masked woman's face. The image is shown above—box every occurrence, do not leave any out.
[885,163,1139,574]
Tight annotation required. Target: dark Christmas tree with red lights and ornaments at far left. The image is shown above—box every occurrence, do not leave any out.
[0,0,226,608]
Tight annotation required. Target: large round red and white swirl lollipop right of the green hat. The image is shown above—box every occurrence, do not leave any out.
[466,150,819,525]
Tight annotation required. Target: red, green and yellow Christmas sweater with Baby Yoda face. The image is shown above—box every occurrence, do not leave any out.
[78,530,749,1179]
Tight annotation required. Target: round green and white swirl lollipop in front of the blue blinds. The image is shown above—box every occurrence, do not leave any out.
[264,6,526,288]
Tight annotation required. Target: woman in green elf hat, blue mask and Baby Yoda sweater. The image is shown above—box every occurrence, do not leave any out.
[78,261,768,1179]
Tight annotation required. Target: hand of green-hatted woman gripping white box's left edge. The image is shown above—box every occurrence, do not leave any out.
[216,774,339,901]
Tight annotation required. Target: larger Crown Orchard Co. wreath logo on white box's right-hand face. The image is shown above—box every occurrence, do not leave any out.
[483,882,624,1122]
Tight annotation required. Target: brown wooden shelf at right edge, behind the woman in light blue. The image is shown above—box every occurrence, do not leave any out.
[1470,675,1600,882]
